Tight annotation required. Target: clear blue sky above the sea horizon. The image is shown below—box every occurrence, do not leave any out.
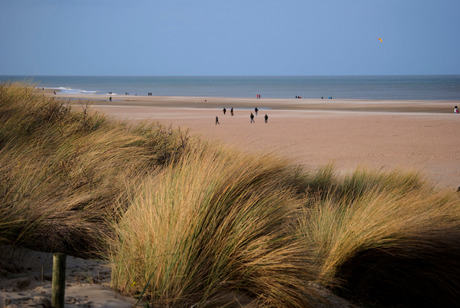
[0,0,460,76]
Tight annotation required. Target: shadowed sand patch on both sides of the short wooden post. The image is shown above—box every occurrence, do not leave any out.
[0,246,136,308]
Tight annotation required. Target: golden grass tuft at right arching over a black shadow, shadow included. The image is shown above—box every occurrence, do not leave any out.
[301,171,460,307]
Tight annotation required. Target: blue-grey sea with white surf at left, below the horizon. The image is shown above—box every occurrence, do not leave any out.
[0,75,460,100]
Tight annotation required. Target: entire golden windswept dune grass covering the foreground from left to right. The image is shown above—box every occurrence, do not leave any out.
[0,84,460,307]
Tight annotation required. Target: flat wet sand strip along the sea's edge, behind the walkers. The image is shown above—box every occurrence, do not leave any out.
[53,92,460,114]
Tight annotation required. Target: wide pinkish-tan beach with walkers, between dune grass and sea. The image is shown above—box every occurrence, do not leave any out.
[57,93,460,189]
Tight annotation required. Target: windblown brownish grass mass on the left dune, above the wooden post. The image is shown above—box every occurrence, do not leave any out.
[0,84,189,254]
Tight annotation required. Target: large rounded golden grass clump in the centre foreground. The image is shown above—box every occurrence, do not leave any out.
[113,149,322,307]
